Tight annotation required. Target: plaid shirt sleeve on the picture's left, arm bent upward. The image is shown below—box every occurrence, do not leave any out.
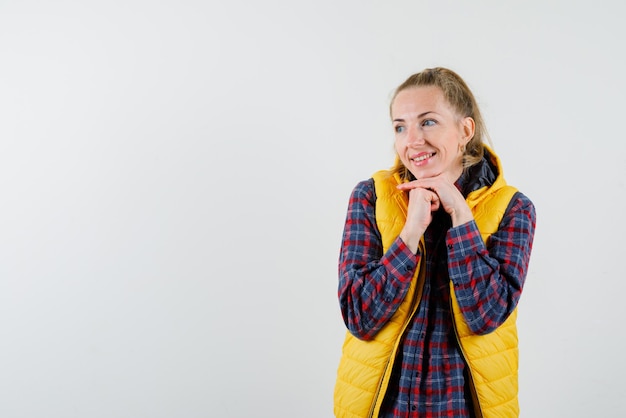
[338,179,420,340]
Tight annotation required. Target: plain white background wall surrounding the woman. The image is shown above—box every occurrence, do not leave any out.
[0,0,626,418]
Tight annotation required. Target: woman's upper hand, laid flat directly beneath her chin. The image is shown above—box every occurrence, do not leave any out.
[398,175,474,226]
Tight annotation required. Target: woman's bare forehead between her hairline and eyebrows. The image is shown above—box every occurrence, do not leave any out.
[391,86,453,116]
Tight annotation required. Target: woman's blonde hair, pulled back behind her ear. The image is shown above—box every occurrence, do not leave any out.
[389,67,491,180]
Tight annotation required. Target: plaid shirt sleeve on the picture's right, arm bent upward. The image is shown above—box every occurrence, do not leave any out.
[446,192,536,334]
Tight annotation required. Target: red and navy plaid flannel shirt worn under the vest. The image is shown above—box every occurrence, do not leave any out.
[339,176,535,418]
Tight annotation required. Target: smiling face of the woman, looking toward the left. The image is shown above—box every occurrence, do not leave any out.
[391,86,474,182]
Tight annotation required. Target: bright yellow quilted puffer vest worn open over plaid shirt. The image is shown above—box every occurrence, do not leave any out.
[334,153,519,418]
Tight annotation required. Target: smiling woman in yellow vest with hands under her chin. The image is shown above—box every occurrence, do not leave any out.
[335,68,535,418]
